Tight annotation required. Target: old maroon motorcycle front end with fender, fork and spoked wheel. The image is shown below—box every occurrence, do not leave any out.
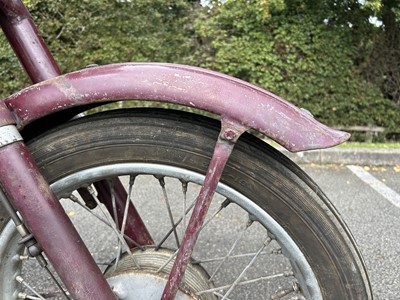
[0,0,372,300]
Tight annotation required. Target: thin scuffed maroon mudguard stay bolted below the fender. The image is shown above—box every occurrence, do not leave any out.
[161,123,245,300]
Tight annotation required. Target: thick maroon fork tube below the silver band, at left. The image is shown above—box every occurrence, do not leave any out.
[0,142,116,300]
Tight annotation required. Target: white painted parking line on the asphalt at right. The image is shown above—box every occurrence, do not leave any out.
[347,166,400,208]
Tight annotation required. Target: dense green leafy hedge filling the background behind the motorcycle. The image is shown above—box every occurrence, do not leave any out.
[0,0,400,141]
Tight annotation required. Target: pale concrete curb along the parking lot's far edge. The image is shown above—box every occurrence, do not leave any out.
[278,148,400,166]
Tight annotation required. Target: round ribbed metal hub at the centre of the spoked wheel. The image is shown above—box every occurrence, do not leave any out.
[105,248,216,300]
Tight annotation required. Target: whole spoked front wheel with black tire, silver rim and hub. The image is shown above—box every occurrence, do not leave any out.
[0,109,372,300]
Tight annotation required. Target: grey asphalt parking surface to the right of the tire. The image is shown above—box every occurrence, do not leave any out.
[302,165,400,300]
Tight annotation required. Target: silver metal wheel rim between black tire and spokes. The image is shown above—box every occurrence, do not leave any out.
[0,163,322,299]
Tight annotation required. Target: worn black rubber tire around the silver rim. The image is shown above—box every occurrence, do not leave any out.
[0,109,372,300]
